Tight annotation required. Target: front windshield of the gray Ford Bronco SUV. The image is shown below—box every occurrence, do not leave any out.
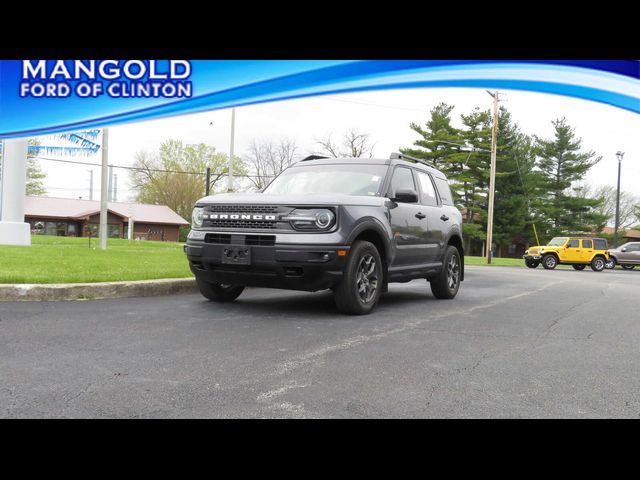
[264,164,388,197]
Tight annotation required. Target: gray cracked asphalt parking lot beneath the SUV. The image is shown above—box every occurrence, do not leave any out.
[0,267,640,418]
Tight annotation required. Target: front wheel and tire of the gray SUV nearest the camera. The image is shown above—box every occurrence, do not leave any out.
[333,240,384,315]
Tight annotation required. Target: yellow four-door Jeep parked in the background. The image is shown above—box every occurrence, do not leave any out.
[522,237,609,272]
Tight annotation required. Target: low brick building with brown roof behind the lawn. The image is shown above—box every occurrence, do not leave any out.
[25,197,189,242]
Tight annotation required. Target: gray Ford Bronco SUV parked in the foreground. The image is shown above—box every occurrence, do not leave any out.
[185,153,464,315]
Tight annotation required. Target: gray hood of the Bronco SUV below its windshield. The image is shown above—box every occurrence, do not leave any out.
[196,193,388,207]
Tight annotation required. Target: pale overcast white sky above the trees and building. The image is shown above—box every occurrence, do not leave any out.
[40,88,640,201]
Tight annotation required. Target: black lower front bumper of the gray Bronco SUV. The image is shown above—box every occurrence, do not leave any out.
[184,239,350,292]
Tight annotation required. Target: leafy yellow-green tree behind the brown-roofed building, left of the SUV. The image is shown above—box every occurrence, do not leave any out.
[130,140,247,220]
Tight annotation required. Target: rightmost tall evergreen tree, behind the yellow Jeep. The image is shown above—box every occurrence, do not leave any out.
[536,118,606,236]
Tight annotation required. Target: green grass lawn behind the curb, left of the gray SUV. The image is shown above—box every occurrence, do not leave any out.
[0,235,192,283]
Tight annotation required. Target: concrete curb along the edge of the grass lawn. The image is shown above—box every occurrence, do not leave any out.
[0,278,198,302]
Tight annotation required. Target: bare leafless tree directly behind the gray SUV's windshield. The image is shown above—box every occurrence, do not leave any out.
[247,138,298,190]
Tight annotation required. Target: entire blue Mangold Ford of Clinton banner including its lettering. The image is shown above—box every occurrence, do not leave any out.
[0,60,640,138]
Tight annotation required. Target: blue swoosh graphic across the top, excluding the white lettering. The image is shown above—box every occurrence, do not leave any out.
[0,60,640,138]
